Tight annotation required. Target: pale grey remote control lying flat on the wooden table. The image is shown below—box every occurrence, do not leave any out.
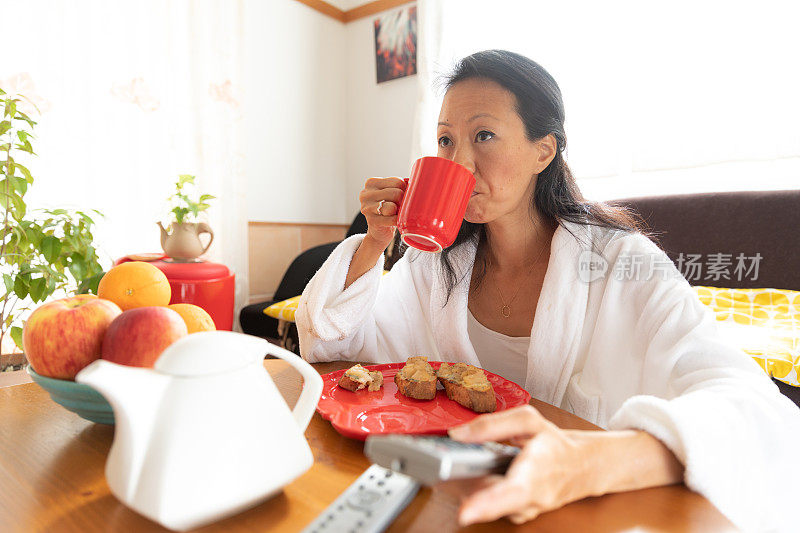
[302,465,419,533]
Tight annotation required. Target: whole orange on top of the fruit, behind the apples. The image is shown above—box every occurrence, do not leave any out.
[97,261,172,311]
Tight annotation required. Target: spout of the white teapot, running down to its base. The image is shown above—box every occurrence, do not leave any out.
[75,359,172,501]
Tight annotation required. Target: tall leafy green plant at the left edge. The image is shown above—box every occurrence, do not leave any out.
[0,89,103,371]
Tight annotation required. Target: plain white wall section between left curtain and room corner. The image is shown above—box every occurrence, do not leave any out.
[244,0,352,224]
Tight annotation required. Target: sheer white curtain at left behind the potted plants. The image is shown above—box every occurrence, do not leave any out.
[0,0,248,324]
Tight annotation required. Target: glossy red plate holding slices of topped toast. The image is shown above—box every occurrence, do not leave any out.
[317,361,531,440]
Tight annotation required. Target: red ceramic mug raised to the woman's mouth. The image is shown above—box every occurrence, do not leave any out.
[397,157,475,252]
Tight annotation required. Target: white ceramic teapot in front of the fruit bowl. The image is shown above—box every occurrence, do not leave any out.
[75,331,322,530]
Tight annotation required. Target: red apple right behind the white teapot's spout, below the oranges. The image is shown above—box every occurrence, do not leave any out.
[103,307,189,367]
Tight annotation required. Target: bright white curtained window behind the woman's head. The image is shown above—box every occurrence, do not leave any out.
[412,0,800,200]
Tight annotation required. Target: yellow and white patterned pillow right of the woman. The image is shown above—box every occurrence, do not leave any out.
[694,287,800,387]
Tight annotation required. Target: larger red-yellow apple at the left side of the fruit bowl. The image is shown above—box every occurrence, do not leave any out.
[22,294,122,379]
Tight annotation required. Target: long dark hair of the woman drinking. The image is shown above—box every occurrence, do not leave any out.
[440,50,641,303]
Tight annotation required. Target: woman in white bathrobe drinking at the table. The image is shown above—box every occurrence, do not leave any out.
[297,50,800,530]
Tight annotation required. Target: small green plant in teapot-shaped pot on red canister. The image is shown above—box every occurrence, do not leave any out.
[157,174,214,261]
